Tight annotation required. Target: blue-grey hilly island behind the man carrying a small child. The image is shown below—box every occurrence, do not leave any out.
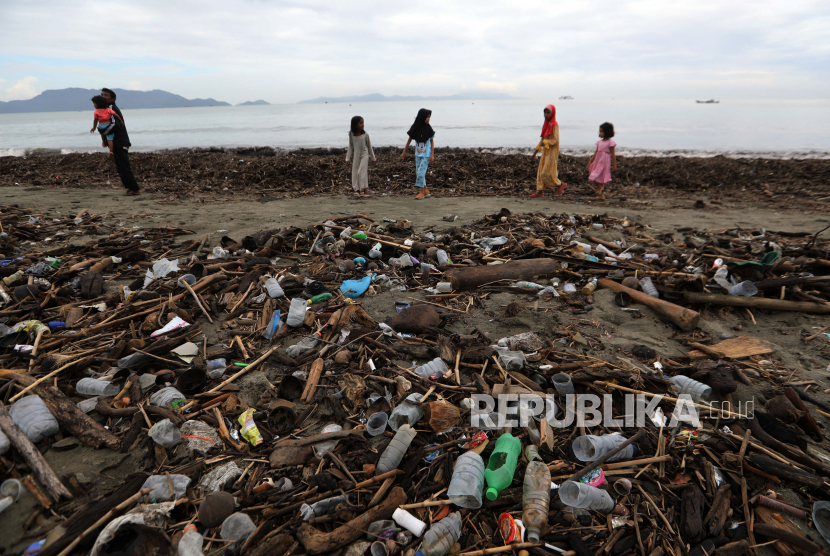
[0,88,230,114]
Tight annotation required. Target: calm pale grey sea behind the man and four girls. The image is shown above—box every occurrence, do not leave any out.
[0,99,830,158]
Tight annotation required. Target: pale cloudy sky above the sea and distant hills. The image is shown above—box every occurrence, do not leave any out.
[0,0,830,104]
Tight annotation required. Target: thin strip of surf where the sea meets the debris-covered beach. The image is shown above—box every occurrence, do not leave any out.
[0,145,830,160]
